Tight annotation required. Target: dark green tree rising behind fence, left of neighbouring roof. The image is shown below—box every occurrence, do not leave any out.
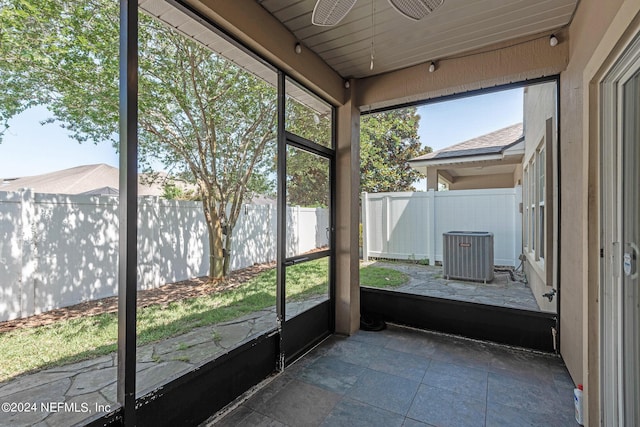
[360,107,431,193]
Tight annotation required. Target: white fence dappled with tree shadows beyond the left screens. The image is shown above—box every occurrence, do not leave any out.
[0,190,329,321]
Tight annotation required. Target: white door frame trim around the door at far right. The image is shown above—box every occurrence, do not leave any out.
[599,33,640,425]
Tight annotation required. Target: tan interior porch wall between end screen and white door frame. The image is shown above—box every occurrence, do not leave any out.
[560,0,640,425]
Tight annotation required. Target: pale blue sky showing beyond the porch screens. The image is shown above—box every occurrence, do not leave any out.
[0,89,522,178]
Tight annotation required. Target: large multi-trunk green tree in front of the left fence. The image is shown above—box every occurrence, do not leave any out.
[0,0,277,278]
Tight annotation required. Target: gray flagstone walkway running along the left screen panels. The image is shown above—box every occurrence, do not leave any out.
[0,295,327,427]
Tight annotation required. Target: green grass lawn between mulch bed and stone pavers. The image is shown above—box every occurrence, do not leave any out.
[0,258,407,382]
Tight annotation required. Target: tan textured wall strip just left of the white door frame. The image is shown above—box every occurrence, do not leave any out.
[560,0,638,425]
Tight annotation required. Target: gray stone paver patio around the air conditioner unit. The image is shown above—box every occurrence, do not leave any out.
[365,261,540,311]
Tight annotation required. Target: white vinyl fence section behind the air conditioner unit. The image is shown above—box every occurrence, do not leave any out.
[362,187,522,266]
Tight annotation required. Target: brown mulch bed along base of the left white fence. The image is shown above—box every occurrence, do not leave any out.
[0,263,276,333]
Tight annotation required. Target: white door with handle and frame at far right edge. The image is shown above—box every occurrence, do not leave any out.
[601,31,640,426]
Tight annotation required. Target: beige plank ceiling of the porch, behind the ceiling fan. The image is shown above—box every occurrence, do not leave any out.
[256,0,579,78]
